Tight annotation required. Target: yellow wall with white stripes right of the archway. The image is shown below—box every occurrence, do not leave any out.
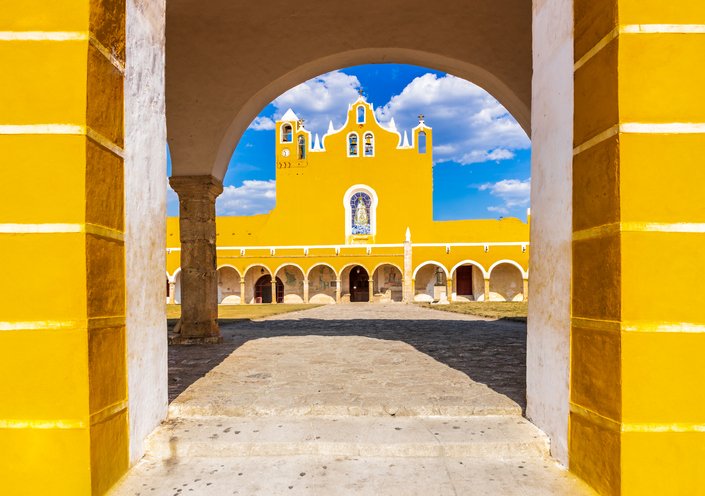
[569,0,705,495]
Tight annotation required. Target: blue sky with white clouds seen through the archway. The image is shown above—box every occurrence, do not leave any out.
[167,64,531,220]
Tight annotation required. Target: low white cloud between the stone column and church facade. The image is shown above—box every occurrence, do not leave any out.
[215,179,276,215]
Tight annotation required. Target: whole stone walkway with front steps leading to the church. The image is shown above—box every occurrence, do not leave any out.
[114,303,593,496]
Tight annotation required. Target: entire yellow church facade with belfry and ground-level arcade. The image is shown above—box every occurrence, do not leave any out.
[167,97,529,304]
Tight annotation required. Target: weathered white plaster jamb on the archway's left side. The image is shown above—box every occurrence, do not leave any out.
[125,0,167,462]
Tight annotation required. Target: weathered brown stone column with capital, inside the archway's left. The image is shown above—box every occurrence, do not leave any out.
[169,176,223,343]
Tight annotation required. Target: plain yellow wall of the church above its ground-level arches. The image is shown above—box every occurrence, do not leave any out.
[167,98,529,296]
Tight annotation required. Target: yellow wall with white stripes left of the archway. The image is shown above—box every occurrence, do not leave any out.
[0,0,128,495]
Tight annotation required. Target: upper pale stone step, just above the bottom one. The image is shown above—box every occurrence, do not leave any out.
[148,416,549,460]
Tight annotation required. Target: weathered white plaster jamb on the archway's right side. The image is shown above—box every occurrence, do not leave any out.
[526,0,573,464]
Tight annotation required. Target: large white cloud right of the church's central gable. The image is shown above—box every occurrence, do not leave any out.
[376,73,531,165]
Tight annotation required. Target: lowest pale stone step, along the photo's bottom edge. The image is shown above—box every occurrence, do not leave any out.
[111,455,595,496]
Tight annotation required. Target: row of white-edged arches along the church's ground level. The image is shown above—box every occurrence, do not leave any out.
[167,260,528,305]
